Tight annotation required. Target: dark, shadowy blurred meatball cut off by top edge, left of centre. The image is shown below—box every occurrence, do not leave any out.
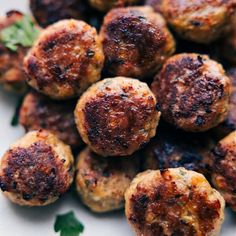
[30,0,85,26]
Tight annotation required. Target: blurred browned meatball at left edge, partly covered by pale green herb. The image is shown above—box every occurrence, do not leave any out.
[0,11,28,93]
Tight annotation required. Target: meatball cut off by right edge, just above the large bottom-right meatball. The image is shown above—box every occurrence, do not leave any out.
[209,131,236,211]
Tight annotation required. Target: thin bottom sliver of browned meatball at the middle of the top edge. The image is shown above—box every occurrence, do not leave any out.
[88,0,140,12]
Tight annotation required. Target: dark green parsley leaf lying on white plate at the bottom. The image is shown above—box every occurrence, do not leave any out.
[54,211,84,236]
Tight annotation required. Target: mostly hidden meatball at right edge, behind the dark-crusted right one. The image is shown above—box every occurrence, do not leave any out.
[213,68,236,139]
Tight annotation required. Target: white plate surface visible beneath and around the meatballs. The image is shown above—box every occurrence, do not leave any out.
[0,0,236,236]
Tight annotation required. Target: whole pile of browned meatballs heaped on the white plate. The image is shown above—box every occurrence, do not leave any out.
[0,0,236,236]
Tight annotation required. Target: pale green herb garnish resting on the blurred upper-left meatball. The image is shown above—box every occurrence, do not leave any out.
[0,15,39,52]
